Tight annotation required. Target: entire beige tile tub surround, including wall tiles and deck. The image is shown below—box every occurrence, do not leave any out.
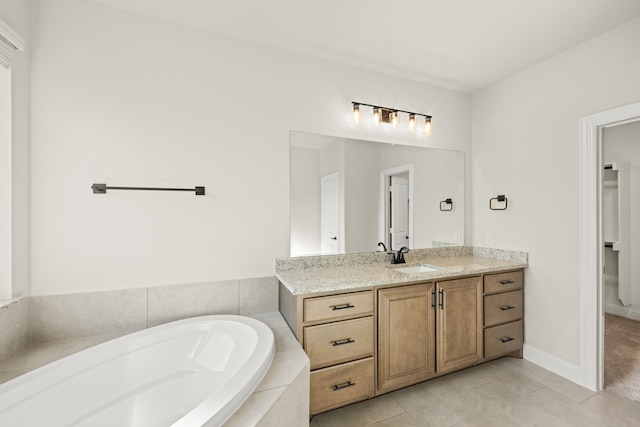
[0,276,300,426]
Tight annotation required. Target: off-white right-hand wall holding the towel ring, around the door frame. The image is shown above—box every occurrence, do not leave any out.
[472,19,640,371]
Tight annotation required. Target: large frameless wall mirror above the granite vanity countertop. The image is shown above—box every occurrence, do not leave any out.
[289,132,464,256]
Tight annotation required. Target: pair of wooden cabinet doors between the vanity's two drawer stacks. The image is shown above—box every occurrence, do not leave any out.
[377,276,483,393]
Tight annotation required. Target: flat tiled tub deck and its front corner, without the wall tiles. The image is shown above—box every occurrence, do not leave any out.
[0,312,309,427]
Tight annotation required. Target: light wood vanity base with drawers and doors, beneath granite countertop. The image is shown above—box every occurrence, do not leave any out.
[279,269,524,415]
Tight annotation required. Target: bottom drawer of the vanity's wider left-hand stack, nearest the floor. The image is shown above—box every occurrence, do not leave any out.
[309,357,373,414]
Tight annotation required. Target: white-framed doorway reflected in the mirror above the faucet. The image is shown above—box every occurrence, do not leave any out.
[379,164,413,250]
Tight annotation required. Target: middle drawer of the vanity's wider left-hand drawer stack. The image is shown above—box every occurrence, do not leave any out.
[304,316,373,370]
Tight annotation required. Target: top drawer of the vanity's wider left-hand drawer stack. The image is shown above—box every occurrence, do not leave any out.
[304,291,373,322]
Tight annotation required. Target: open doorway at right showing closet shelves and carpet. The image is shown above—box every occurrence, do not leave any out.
[601,121,640,402]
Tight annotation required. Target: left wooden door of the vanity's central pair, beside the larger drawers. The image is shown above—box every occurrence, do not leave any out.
[378,283,435,393]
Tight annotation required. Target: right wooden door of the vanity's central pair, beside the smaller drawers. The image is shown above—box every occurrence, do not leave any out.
[436,277,483,373]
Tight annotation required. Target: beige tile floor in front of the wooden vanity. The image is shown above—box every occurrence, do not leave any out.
[310,358,640,427]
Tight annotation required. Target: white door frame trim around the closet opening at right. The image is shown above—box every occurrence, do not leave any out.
[579,102,640,391]
